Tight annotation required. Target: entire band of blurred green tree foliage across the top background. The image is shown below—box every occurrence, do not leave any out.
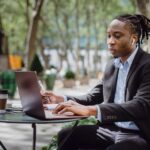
[0,0,135,53]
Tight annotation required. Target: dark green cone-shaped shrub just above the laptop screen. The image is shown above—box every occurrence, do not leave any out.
[30,54,44,74]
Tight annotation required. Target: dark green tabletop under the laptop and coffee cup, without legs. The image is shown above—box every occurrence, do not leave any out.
[0,111,85,124]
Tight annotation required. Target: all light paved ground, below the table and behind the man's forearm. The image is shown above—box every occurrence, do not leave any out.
[0,80,97,150]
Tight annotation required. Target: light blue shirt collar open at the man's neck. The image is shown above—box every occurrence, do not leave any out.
[114,47,138,68]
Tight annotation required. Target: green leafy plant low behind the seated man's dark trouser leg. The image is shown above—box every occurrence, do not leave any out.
[42,117,97,150]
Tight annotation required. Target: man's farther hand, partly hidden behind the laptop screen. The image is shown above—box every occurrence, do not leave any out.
[41,91,64,104]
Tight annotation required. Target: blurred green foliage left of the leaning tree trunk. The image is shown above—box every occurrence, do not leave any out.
[0,0,28,53]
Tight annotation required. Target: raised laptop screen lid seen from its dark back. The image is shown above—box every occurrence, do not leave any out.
[15,71,45,119]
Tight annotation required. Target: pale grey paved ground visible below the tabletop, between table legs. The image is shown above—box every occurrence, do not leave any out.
[0,123,62,150]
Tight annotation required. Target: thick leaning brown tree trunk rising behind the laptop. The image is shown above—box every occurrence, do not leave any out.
[26,0,44,68]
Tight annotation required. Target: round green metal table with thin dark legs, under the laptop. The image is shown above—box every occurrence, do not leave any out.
[0,112,82,150]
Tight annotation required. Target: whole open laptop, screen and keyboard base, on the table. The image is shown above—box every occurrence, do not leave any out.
[15,71,87,120]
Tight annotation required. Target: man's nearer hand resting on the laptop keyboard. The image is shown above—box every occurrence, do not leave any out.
[53,101,97,116]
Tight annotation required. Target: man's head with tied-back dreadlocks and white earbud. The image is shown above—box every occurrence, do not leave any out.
[107,15,150,61]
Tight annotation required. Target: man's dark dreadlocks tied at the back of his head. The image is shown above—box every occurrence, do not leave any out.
[115,14,150,46]
